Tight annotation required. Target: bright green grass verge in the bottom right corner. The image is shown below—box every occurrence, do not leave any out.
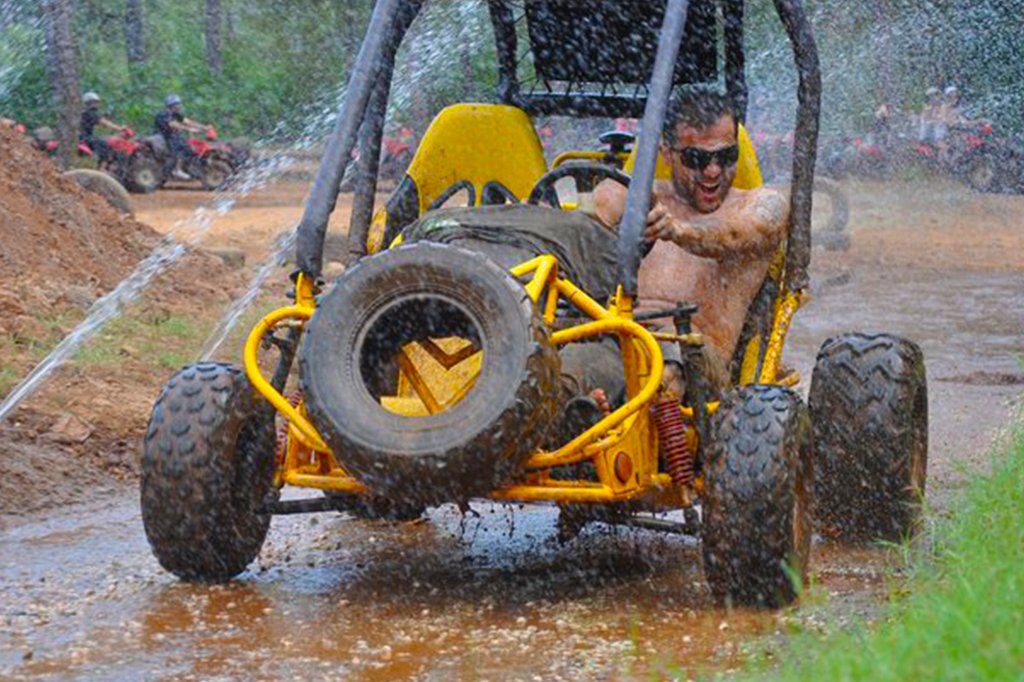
[745,420,1024,680]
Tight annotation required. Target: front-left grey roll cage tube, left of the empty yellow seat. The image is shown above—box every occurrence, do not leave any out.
[295,0,422,280]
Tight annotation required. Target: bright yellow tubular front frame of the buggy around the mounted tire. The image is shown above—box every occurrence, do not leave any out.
[244,255,790,506]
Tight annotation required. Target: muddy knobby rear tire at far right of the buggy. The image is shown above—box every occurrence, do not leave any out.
[808,334,928,541]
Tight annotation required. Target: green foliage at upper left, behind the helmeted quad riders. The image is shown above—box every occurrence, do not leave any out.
[0,0,372,137]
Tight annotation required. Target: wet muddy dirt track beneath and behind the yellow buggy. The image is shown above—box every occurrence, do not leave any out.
[0,174,1024,680]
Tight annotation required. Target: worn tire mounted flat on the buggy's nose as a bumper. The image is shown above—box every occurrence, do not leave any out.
[299,242,560,505]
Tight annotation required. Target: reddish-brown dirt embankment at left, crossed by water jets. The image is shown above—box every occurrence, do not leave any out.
[0,124,243,512]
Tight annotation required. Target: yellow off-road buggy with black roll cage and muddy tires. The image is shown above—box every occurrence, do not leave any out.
[141,0,928,606]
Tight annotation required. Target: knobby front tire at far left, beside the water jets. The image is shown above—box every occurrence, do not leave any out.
[141,363,275,582]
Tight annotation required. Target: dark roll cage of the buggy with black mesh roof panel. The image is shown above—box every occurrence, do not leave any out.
[296,0,821,295]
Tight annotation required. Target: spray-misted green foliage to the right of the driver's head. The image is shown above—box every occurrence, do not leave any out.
[745,0,1024,133]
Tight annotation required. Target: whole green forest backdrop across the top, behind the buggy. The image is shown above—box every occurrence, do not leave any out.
[0,0,1024,148]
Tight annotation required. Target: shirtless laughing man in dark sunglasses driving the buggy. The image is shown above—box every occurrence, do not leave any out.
[563,86,788,408]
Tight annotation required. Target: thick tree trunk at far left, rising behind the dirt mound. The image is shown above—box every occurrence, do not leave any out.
[43,0,80,168]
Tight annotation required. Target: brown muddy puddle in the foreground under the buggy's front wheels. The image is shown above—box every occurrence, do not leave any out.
[0,491,883,680]
